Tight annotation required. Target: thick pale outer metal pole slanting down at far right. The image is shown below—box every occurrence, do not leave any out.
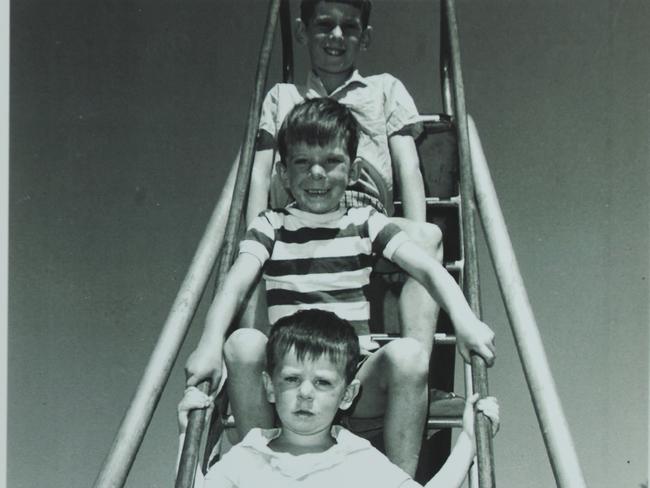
[469,116,586,488]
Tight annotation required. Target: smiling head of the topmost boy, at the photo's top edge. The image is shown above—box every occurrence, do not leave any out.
[296,1,370,88]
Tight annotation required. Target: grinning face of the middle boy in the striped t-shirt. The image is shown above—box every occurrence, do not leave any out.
[277,138,359,214]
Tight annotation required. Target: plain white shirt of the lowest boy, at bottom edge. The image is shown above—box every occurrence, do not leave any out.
[196,426,421,488]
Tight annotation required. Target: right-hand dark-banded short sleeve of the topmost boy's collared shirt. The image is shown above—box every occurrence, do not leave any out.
[384,75,422,138]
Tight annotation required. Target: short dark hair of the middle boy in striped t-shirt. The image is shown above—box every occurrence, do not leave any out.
[278,98,359,162]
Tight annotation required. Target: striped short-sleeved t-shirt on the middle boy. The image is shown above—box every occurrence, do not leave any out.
[239,206,408,333]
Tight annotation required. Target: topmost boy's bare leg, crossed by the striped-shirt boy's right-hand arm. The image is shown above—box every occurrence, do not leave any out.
[384,217,443,357]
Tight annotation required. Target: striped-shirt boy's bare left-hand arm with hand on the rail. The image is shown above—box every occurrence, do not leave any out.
[185,253,262,388]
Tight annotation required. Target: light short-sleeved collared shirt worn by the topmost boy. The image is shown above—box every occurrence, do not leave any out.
[259,71,421,214]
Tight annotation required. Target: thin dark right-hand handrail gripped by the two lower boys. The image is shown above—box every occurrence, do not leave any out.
[441,0,495,488]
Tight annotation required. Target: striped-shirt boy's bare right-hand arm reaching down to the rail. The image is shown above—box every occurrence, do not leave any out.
[393,241,495,365]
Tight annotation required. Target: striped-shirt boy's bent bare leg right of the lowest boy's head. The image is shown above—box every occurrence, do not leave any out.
[352,339,429,476]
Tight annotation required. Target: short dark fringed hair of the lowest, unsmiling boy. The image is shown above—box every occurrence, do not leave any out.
[266,309,360,384]
